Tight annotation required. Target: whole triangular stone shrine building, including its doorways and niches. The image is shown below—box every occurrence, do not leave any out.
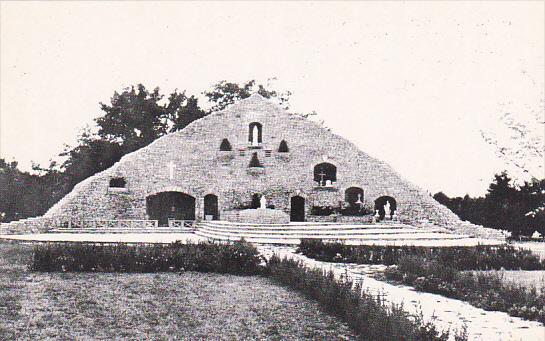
[38,94,478,234]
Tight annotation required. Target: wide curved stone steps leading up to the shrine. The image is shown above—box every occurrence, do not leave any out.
[195,221,471,244]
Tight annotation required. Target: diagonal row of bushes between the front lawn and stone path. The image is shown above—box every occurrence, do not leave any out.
[267,256,460,340]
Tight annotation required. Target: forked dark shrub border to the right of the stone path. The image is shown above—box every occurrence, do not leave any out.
[298,239,545,323]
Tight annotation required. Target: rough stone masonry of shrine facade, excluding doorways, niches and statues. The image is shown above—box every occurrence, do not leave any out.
[3,91,499,237]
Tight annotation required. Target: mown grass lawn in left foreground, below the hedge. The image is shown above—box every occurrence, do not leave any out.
[0,243,355,340]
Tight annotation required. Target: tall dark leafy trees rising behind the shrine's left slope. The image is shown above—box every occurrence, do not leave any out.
[60,84,206,190]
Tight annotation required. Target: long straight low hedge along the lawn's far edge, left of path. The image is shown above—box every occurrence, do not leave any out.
[31,241,263,275]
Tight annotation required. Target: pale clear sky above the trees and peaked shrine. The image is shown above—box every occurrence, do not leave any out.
[0,1,545,196]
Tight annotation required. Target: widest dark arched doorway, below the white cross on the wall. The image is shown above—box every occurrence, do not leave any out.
[146,192,195,226]
